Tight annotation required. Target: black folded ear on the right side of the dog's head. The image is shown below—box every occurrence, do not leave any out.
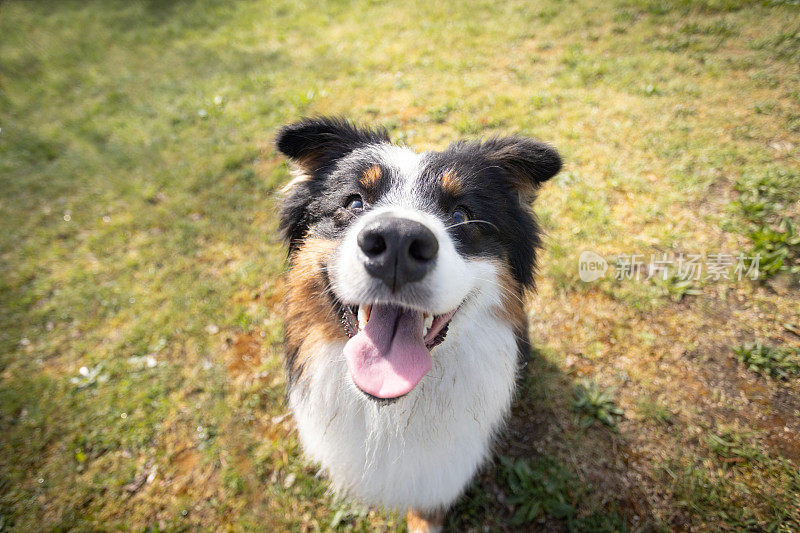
[480,135,561,195]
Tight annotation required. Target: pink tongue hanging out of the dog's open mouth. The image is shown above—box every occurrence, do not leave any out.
[344,304,432,398]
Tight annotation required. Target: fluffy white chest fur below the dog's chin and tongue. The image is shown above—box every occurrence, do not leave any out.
[289,300,517,510]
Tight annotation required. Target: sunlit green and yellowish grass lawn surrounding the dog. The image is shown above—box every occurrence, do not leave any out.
[0,0,800,531]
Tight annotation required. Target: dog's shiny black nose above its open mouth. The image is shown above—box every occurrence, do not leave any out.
[358,217,439,292]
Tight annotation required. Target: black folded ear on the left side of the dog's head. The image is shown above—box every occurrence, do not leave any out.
[275,117,389,177]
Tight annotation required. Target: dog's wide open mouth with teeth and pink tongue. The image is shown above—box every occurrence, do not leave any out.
[342,304,456,399]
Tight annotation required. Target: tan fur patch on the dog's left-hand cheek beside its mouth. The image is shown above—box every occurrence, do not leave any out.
[285,239,347,370]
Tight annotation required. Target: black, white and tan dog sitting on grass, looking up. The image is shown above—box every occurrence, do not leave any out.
[276,117,561,531]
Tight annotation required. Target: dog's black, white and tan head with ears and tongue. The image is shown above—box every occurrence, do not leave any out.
[277,119,561,399]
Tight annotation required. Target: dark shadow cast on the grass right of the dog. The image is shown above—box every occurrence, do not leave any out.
[447,349,663,531]
